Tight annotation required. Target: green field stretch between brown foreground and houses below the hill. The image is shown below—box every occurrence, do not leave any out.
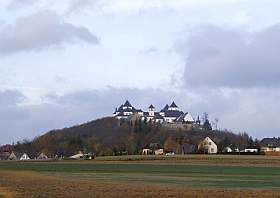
[0,156,280,197]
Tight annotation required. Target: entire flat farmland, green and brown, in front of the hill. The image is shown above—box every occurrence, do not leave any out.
[0,155,280,198]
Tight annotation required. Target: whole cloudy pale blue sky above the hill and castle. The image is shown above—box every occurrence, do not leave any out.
[0,0,280,144]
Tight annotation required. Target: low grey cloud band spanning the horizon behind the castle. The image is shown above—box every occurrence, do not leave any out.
[0,87,280,144]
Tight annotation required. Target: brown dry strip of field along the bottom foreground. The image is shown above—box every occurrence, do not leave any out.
[0,171,280,198]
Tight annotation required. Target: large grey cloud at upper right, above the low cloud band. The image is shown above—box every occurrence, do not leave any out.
[178,24,280,88]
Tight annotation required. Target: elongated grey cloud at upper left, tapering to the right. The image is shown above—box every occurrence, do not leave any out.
[0,11,99,54]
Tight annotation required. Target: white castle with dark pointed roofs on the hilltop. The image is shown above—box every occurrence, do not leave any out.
[113,100,200,128]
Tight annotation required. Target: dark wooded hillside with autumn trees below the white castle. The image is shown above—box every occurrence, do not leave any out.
[14,117,259,157]
